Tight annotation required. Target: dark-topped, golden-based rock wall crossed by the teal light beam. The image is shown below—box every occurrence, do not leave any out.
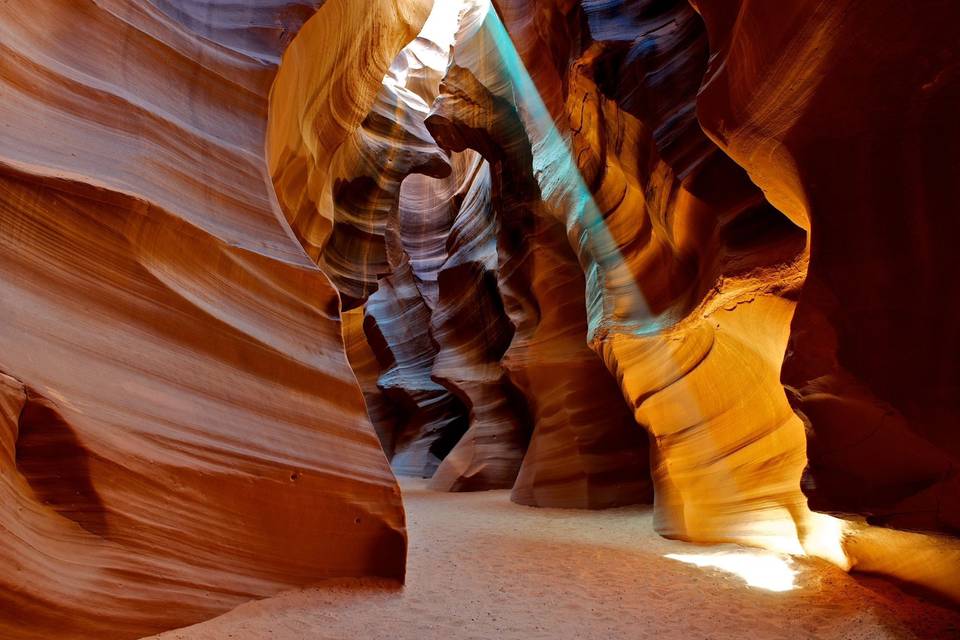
[462,2,804,551]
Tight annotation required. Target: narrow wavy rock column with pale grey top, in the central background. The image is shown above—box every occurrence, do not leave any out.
[430,152,530,491]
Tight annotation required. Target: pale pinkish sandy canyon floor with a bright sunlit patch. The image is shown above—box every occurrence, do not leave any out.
[155,480,960,640]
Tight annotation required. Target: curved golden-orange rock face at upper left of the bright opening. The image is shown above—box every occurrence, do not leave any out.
[267,0,442,264]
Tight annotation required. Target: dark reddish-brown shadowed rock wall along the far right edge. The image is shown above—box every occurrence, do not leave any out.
[695,0,960,534]
